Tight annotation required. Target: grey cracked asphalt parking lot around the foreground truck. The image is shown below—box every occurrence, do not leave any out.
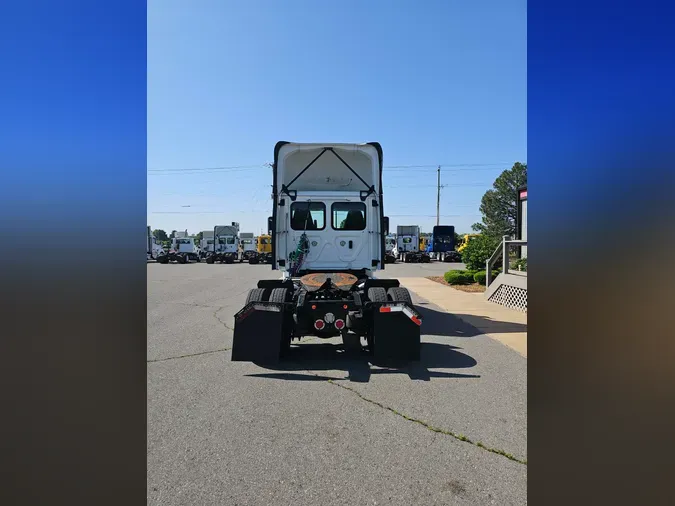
[147,263,527,506]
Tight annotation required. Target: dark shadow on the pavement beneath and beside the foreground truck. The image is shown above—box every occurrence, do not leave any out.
[249,306,480,383]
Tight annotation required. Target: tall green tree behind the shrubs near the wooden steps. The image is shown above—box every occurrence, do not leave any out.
[471,162,527,239]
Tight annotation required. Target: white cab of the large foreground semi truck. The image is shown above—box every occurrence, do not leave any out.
[272,143,384,277]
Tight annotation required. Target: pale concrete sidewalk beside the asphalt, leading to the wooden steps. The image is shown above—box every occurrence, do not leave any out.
[398,278,527,358]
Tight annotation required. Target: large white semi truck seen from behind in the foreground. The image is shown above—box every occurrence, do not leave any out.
[232,142,422,363]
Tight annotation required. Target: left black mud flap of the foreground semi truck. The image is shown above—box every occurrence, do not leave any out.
[232,302,289,363]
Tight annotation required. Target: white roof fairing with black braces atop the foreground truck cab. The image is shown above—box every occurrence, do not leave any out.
[273,141,382,195]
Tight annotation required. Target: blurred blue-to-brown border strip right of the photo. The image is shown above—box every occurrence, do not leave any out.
[528,1,675,504]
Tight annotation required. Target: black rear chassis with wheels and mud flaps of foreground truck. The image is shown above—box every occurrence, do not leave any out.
[232,272,422,363]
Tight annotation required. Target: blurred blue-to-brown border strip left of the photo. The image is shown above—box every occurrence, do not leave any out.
[0,0,147,505]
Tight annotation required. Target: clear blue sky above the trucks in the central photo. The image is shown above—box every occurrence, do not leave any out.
[147,0,527,237]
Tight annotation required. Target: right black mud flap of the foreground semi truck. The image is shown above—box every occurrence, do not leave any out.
[373,302,422,361]
